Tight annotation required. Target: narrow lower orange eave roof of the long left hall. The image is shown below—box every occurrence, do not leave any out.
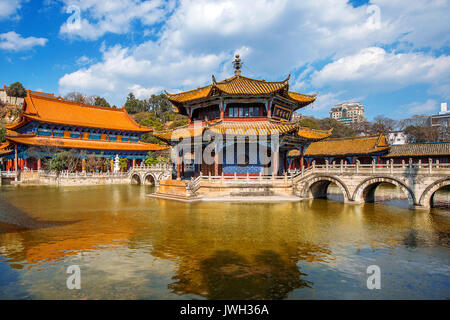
[6,134,167,151]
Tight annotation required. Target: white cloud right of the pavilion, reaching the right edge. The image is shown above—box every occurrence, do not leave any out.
[311,47,450,91]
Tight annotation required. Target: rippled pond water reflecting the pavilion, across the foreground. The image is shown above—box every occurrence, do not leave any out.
[0,185,450,299]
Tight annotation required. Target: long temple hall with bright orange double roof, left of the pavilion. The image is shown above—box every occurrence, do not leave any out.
[0,91,165,171]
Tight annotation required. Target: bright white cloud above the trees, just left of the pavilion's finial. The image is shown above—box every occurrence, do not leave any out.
[59,45,229,104]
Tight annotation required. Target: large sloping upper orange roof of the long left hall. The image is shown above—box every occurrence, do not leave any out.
[8,91,152,132]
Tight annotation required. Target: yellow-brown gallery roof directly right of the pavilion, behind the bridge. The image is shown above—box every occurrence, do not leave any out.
[305,134,389,156]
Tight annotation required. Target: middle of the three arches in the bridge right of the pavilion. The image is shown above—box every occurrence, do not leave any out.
[353,177,416,206]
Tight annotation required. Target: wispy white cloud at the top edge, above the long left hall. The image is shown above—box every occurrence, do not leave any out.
[60,0,174,40]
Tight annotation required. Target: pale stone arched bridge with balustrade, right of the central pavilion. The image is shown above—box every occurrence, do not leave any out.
[293,162,450,209]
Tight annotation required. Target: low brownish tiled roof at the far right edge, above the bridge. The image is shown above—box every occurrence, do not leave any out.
[385,142,450,157]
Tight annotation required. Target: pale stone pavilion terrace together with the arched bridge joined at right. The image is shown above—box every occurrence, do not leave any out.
[186,162,450,209]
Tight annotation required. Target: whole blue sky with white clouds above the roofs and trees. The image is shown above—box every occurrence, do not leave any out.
[0,0,450,120]
